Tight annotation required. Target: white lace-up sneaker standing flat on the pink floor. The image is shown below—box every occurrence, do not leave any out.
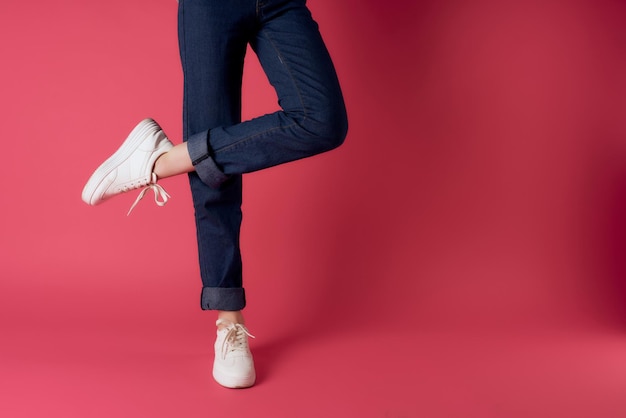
[213,319,256,389]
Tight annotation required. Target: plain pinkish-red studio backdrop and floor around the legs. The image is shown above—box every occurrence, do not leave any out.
[0,0,626,418]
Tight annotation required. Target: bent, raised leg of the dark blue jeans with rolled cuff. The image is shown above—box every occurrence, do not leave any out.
[188,0,347,187]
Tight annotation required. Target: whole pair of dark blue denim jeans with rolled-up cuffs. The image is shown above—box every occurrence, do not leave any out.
[178,0,347,311]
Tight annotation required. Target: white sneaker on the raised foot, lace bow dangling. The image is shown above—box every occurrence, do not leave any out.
[82,119,174,214]
